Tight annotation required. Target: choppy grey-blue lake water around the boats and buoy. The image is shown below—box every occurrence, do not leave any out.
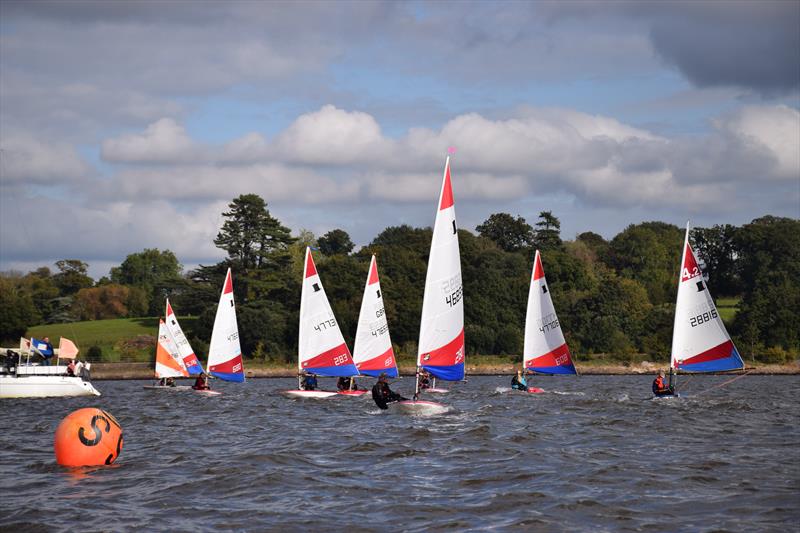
[0,376,800,532]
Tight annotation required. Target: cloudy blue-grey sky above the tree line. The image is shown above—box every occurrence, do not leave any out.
[0,0,800,278]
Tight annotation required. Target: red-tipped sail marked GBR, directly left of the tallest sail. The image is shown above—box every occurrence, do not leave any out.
[353,255,399,378]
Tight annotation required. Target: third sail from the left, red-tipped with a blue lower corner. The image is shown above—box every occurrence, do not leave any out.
[208,268,244,382]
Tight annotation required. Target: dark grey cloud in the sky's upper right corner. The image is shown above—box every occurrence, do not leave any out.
[539,0,800,95]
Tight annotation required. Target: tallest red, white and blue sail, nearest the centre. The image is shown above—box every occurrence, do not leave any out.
[417,157,465,381]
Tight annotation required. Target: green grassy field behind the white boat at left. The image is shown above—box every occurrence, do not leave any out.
[25,317,194,362]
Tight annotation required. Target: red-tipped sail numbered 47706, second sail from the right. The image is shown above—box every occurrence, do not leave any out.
[523,250,577,393]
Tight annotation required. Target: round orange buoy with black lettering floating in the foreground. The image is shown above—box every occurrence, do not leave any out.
[55,407,122,466]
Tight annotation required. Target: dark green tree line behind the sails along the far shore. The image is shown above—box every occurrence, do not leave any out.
[0,194,800,362]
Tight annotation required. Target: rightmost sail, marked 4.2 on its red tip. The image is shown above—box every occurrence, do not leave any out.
[669,222,744,390]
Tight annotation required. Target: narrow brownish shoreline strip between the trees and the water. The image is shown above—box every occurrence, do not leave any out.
[92,362,800,381]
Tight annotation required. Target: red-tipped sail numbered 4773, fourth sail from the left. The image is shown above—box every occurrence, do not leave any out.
[297,247,358,376]
